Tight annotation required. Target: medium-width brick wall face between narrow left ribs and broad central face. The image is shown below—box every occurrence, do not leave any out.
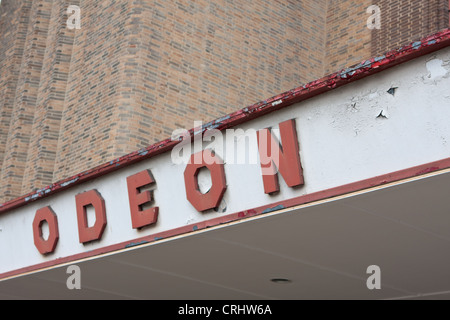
[52,0,135,180]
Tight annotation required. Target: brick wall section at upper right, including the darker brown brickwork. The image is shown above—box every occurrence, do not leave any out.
[324,0,449,74]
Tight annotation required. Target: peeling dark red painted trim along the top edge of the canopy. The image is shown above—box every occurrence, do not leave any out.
[0,29,450,214]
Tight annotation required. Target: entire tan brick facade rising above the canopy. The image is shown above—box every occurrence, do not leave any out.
[0,0,448,203]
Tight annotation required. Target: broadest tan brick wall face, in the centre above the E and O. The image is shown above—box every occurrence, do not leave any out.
[120,0,325,145]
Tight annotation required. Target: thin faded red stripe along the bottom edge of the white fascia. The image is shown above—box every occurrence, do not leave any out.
[0,158,450,280]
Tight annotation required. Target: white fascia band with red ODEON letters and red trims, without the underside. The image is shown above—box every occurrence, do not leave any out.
[4,31,450,279]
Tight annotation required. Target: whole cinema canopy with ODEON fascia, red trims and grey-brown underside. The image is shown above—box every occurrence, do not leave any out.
[0,30,450,299]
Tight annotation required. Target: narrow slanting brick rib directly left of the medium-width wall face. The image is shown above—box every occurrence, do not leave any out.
[22,0,79,194]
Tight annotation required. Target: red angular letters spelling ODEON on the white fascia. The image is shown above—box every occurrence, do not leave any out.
[33,119,304,255]
